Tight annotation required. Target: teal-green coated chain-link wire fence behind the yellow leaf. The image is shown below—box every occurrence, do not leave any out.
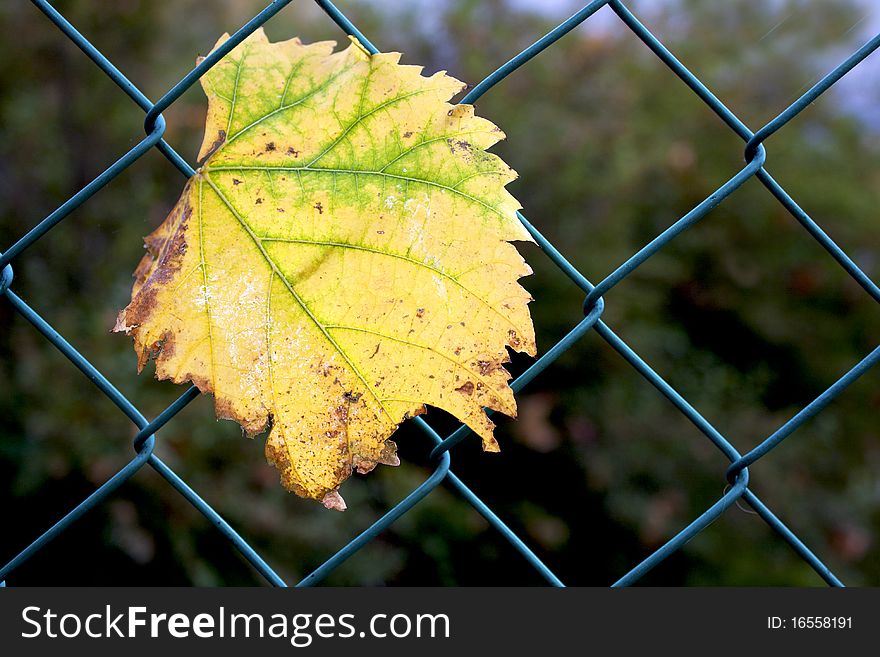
[0,0,880,586]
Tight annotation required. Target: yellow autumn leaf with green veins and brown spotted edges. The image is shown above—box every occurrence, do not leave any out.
[115,30,535,509]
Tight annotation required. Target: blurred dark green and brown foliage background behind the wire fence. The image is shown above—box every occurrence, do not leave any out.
[0,0,880,585]
